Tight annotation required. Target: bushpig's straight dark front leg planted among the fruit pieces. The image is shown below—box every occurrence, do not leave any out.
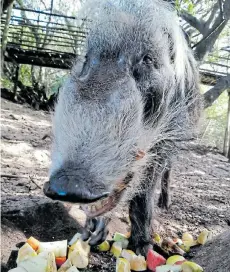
[129,167,155,255]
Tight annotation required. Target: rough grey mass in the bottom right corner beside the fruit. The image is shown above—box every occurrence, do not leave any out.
[192,230,230,272]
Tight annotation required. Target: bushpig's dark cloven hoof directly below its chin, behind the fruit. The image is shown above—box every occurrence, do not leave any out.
[82,217,108,246]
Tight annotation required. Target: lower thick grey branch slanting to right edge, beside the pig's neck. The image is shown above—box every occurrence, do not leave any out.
[204,75,230,108]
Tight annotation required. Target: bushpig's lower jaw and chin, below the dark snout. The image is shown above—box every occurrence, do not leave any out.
[81,182,127,217]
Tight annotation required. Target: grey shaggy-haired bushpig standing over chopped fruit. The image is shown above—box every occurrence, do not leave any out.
[44,0,202,254]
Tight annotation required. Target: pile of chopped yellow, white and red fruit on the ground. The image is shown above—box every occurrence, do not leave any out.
[9,230,212,272]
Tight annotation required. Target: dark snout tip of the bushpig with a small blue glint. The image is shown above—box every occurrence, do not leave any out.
[43,177,109,203]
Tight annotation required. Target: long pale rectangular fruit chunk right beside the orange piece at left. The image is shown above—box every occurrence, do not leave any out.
[38,240,67,257]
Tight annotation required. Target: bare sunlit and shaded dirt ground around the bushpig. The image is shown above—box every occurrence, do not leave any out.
[1,99,230,271]
